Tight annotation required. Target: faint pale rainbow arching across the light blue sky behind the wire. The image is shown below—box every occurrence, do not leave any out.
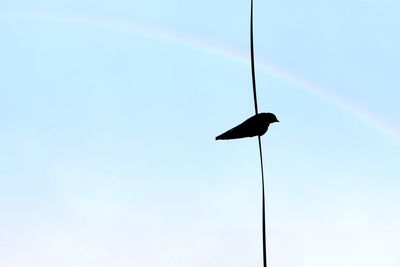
[0,11,400,145]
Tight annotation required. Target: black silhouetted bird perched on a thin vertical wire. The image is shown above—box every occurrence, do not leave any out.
[215,112,279,140]
